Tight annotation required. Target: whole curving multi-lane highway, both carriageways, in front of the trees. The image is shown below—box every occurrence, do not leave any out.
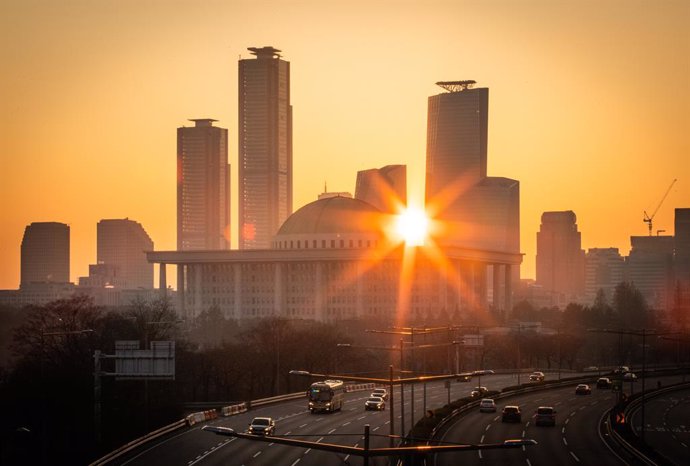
[113,375,687,466]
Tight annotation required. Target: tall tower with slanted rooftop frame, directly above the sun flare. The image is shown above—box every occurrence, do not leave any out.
[426,81,489,207]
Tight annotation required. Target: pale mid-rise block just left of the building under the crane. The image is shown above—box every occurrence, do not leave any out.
[585,248,625,305]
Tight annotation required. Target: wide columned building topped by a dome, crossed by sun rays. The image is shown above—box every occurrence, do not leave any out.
[147,196,522,321]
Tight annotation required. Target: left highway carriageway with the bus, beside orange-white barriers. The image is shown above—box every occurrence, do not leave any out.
[117,375,525,466]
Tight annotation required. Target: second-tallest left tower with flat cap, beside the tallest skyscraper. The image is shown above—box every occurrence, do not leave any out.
[177,118,230,251]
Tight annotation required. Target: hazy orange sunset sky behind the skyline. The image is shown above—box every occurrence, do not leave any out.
[0,0,690,289]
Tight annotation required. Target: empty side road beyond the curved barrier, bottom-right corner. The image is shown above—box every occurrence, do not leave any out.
[632,389,690,465]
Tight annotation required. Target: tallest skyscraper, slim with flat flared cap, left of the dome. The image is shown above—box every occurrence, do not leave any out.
[238,47,292,249]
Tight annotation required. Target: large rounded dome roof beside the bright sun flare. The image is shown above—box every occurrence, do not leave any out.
[276,196,383,237]
